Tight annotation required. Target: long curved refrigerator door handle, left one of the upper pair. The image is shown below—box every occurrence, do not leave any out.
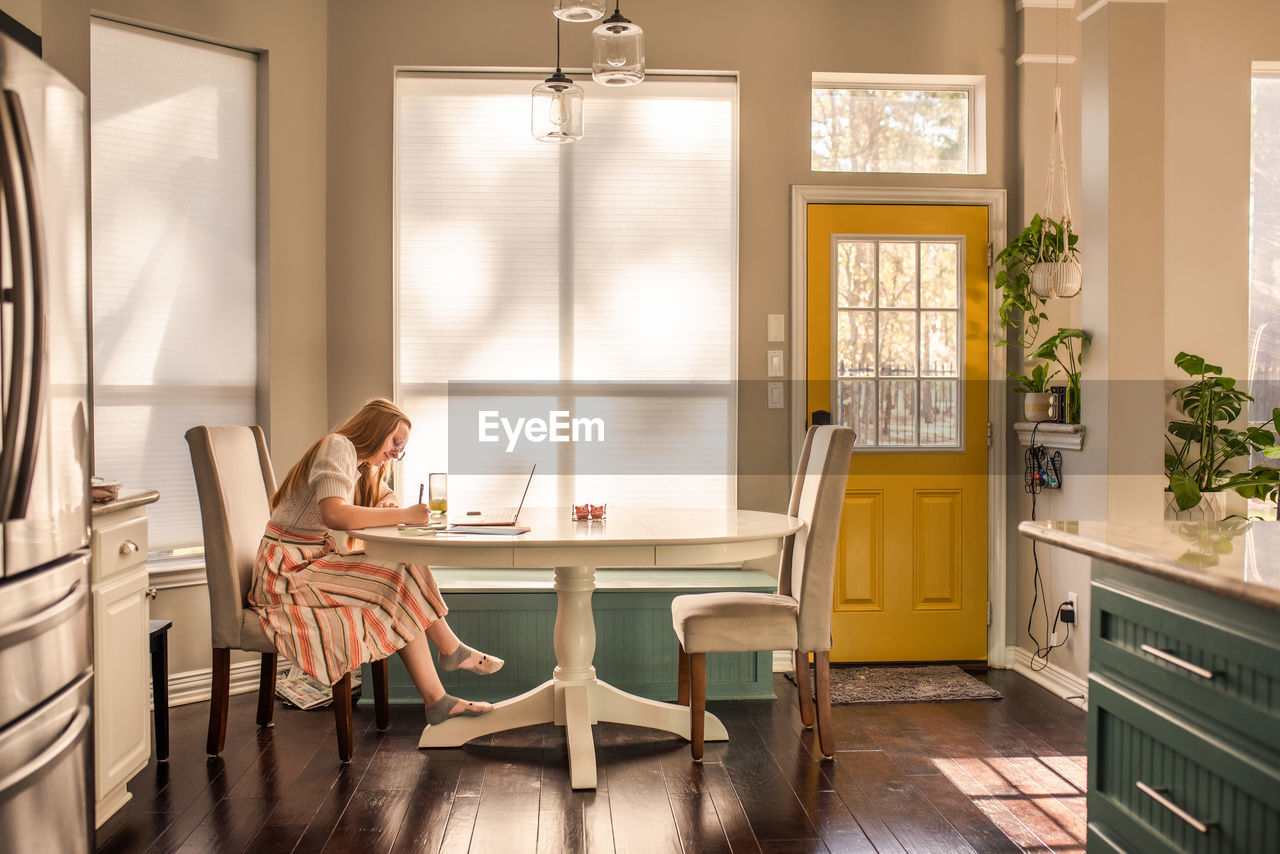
[0,90,27,520]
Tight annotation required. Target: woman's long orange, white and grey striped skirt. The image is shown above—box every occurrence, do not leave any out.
[248,522,449,685]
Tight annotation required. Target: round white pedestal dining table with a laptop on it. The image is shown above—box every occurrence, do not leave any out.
[351,506,804,789]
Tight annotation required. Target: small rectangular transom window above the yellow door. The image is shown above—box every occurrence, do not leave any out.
[809,72,987,174]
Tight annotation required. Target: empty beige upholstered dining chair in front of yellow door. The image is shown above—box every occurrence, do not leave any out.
[671,426,854,761]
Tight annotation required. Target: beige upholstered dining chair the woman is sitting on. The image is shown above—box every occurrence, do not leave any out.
[187,426,389,763]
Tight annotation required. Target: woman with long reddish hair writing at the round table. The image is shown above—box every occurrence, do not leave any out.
[248,398,503,725]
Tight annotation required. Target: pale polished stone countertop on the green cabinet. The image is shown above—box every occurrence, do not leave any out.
[1018,519,1280,612]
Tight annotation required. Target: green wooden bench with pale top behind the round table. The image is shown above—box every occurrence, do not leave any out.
[362,568,777,703]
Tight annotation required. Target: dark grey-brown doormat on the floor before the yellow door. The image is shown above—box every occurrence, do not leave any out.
[787,665,1002,705]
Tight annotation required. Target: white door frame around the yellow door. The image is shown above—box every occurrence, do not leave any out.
[788,184,1009,667]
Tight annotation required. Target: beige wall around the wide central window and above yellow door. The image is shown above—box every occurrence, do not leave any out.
[328,0,1016,510]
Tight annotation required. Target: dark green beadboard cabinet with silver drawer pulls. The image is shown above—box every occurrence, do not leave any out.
[1088,561,1280,854]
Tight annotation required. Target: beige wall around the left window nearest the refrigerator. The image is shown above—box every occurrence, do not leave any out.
[12,0,329,673]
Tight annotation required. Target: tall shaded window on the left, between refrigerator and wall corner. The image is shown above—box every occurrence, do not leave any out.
[90,19,257,552]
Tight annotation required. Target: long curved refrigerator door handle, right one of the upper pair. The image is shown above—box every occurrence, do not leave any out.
[5,90,49,519]
